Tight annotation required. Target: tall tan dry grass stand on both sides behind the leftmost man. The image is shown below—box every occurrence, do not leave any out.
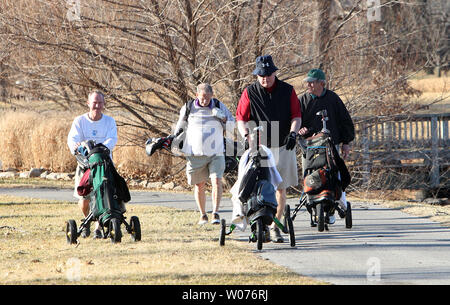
[0,111,179,178]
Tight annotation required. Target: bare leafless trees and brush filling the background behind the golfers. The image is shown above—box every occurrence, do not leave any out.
[0,0,449,140]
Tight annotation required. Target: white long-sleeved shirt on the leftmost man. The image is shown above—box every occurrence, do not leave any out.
[67,113,117,154]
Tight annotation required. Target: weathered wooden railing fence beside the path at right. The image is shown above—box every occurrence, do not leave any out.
[348,113,450,188]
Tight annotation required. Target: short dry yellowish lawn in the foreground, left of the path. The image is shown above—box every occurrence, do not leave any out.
[0,196,319,285]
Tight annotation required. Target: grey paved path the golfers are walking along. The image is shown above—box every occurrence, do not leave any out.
[0,188,450,285]
